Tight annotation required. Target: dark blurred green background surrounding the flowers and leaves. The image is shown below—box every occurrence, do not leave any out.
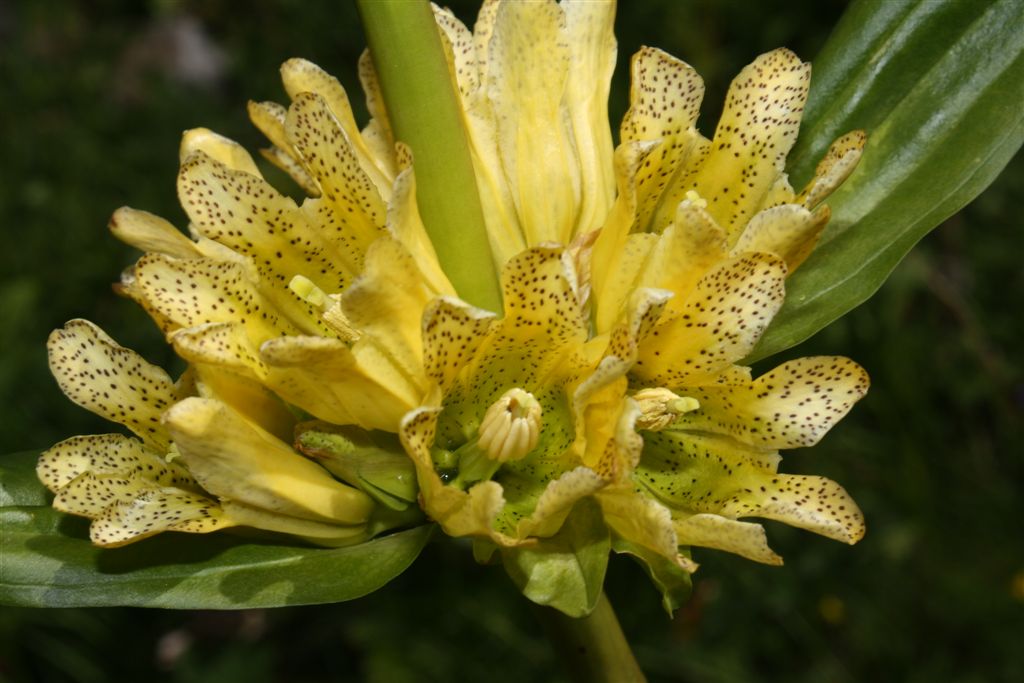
[0,0,1024,683]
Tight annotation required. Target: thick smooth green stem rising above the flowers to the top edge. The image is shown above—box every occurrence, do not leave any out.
[356,0,502,311]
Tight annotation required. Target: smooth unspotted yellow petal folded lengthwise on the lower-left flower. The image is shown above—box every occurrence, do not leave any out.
[164,398,373,524]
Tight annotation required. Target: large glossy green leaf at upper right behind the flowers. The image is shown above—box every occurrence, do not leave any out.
[746,0,1024,362]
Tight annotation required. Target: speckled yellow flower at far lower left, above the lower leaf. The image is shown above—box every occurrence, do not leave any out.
[37,321,391,546]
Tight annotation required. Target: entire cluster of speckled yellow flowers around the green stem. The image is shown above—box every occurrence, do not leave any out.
[39,0,868,610]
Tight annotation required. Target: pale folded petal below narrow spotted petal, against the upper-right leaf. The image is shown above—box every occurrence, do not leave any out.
[732,204,830,272]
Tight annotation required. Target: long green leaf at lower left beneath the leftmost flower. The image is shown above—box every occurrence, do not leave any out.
[0,453,433,609]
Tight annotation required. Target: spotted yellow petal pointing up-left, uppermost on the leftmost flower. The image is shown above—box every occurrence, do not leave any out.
[46,319,178,452]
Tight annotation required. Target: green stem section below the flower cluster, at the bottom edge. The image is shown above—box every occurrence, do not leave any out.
[537,591,647,683]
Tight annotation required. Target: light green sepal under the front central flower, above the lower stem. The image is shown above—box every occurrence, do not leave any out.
[502,499,611,617]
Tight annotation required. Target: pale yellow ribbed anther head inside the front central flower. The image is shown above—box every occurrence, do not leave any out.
[477,389,541,463]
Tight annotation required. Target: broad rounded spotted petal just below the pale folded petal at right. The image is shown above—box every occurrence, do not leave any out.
[633,254,785,390]
